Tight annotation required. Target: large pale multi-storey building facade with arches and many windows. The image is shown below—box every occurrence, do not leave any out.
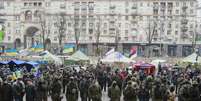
[0,0,199,56]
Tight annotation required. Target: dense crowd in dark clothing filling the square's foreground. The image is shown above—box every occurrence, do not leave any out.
[0,63,201,101]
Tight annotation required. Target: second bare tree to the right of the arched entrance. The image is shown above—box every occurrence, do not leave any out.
[56,13,66,54]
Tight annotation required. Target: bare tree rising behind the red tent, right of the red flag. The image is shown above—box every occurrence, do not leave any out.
[146,19,157,57]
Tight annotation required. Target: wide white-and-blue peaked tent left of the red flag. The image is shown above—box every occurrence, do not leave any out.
[101,52,135,63]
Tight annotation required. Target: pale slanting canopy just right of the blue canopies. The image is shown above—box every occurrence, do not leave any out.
[40,51,62,64]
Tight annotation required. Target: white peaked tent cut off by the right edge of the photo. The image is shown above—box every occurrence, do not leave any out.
[182,53,201,63]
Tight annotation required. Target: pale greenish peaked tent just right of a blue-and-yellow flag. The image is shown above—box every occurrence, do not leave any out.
[69,50,89,61]
